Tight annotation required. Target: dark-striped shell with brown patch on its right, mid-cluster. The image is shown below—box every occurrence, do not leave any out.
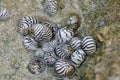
[55,44,73,59]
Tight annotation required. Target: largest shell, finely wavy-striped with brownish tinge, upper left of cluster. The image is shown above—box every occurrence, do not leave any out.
[30,24,53,42]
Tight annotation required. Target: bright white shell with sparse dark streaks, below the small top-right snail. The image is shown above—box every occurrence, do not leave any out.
[55,28,74,43]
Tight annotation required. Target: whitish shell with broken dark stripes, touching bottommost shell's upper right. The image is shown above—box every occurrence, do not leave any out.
[71,49,86,67]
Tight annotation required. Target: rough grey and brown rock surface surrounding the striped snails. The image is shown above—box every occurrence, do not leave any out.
[0,0,120,80]
